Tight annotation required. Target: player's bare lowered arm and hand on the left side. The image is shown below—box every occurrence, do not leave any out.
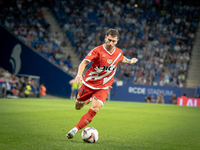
[75,60,89,84]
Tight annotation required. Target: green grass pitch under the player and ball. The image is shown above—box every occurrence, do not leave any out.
[0,98,200,150]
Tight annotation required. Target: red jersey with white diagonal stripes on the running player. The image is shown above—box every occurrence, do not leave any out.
[82,44,124,89]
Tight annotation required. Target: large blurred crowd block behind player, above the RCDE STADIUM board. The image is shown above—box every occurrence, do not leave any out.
[51,0,199,87]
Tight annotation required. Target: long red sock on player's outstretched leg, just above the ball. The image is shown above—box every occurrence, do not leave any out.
[76,108,96,130]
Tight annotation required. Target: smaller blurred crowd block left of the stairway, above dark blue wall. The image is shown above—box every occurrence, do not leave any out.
[0,0,72,72]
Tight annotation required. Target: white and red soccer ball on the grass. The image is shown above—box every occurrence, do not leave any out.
[81,127,99,143]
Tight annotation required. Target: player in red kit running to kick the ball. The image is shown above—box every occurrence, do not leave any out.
[66,29,138,139]
